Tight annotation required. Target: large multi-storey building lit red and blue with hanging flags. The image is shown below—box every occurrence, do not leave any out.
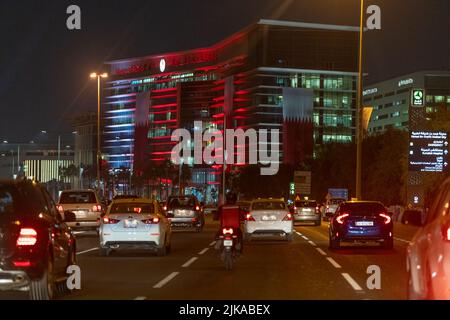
[103,20,358,200]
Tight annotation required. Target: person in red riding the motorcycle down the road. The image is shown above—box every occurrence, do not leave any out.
[216,191,244,253]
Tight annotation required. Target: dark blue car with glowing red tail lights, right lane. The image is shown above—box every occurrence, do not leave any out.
[329,201,394,249]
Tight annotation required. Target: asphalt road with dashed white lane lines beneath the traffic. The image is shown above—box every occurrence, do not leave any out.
[0,219,414,300]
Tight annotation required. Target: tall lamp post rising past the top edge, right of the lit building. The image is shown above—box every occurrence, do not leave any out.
[356,0,364,200]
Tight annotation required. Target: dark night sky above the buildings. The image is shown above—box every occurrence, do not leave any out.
[0,0,450,142]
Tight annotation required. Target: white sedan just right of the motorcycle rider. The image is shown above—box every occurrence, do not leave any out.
[244,199,294,241]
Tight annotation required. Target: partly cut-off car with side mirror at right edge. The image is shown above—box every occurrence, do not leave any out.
[402,179,450,300]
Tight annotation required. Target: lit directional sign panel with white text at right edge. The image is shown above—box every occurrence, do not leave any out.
[409,131,448,172]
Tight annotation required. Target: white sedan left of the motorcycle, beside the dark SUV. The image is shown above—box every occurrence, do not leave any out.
[99,198,172,256]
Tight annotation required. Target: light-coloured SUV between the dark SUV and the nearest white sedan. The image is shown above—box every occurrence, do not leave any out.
[58,189,103,230]
